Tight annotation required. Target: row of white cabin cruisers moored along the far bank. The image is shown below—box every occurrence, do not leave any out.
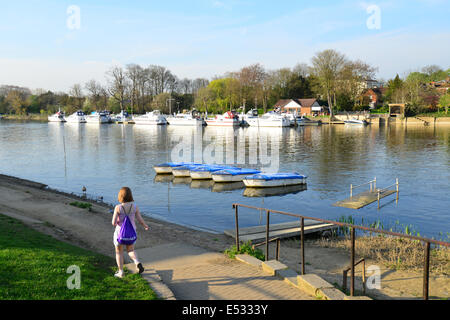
[48,109,322,127]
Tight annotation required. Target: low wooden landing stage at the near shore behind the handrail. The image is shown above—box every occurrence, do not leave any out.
[224,220,336,242]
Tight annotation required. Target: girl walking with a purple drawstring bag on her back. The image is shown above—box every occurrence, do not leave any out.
[112,187,149,278]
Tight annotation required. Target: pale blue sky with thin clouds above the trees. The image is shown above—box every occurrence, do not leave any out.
[0,0,450,92]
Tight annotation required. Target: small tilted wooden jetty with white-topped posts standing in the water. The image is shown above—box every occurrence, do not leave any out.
[333,178,399,209]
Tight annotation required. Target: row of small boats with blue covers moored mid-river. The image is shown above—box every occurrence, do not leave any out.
[154,162,307,188]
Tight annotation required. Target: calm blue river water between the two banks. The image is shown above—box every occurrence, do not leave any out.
[0,120,450,240]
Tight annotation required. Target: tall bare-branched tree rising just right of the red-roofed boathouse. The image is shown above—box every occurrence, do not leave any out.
[311,50,347,117]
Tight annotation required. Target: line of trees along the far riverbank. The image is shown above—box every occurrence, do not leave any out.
[0,50,450,115]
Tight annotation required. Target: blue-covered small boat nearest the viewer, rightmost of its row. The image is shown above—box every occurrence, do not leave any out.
[243,173,307,188]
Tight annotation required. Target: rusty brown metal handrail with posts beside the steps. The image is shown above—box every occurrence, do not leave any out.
[233,203,450,300]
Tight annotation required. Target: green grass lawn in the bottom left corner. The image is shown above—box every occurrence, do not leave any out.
[0,215,157,300]
